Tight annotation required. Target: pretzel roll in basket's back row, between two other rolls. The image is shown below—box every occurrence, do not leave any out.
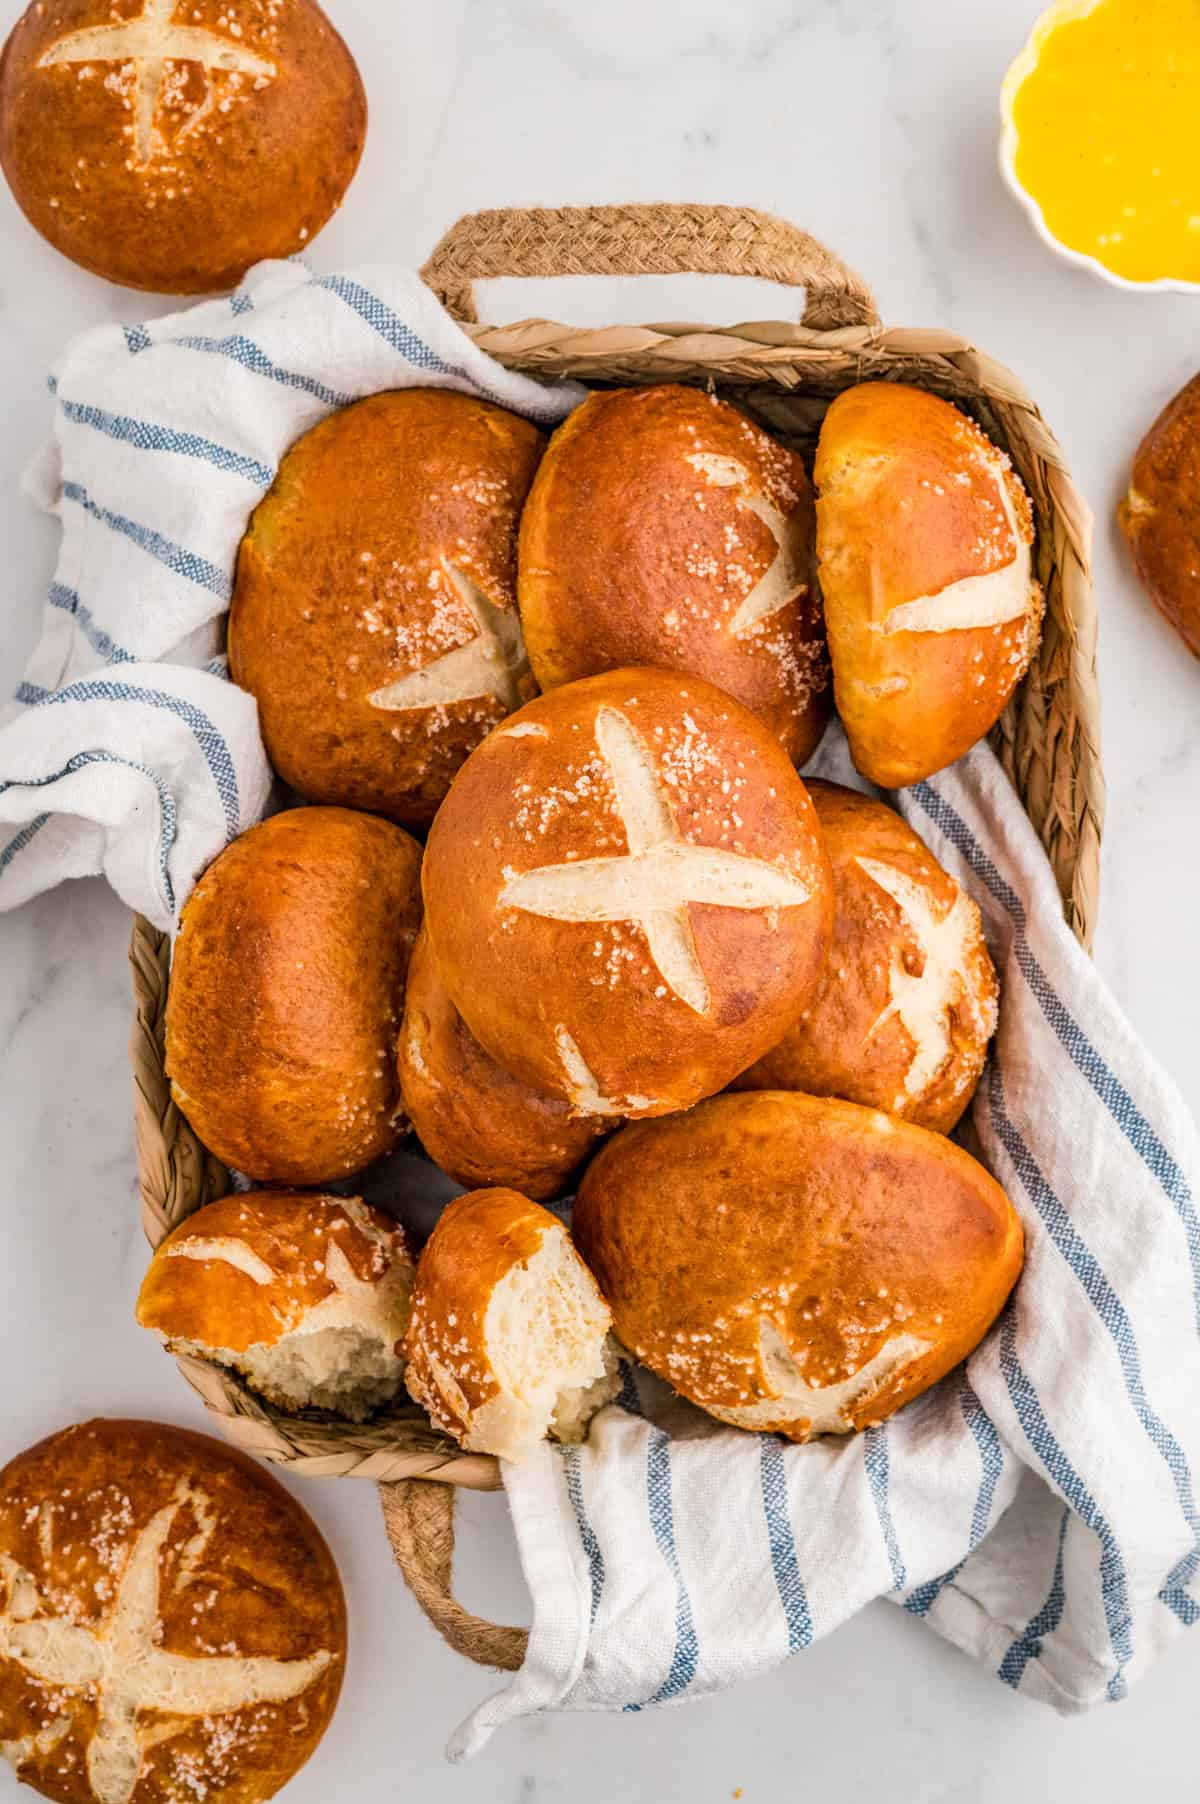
[520,384,828,765]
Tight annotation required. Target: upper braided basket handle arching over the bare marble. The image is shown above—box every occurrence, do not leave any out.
[420,204,879,332]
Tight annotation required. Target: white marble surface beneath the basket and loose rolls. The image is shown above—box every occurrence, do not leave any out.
[0,0,1200,1804]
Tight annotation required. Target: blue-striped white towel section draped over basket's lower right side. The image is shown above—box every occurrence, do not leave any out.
[451,732,1200,1757]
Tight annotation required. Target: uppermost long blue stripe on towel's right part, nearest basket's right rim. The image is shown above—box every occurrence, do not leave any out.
[909,783,1200,1331]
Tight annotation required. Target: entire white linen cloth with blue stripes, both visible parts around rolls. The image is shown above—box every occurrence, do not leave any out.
[0,263,1200,1755]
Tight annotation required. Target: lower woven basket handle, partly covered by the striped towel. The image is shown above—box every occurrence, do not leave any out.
[379,1477,529,1672]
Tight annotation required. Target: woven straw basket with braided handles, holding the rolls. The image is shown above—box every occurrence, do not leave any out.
[130,206,1104,1669]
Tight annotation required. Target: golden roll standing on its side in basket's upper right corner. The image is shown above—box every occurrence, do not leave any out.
[816,382,1041,788]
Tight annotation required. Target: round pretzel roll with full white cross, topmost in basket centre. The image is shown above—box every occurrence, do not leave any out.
[422,669,832,1115]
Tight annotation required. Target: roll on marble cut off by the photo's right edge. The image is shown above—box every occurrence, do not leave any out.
[1119,375,1200,658]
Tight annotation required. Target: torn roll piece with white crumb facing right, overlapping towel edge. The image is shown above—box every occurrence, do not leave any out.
[408,1189,619,1459]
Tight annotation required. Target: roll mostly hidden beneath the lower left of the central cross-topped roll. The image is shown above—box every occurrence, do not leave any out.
[399,929,612,1200]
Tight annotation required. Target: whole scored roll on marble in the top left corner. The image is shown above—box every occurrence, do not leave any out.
[0,0,366,294]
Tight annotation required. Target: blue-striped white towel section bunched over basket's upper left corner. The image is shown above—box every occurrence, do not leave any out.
[0,262,583,929]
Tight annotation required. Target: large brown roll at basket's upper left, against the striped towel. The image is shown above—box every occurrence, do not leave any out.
[229,388,541,826]
